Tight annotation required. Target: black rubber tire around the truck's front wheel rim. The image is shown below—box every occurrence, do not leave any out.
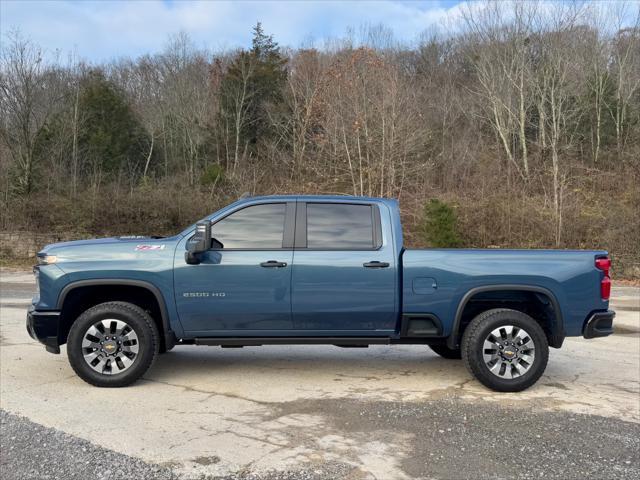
[67,302,160,387]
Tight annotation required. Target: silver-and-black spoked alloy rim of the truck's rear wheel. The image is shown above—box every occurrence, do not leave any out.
[482,325,536,379]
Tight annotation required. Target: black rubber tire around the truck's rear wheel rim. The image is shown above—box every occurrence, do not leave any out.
[462,309,549,392]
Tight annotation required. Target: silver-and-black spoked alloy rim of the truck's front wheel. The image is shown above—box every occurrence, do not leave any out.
[82,319,139,375]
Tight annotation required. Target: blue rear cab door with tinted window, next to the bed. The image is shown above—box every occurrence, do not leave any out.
[291,202,396,336]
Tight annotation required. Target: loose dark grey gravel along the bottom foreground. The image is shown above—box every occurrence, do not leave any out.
[0,398,640,480]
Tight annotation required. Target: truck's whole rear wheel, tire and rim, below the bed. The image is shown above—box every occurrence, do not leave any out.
[462,309,549,392]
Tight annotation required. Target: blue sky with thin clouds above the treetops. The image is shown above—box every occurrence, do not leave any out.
[0,0,468,62]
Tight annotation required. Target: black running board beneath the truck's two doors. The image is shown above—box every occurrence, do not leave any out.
[194,337,391,347]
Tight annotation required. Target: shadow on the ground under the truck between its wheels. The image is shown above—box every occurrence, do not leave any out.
[147,346,470,384]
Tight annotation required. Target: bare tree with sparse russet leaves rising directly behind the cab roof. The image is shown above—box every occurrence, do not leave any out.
[315,48,422,195]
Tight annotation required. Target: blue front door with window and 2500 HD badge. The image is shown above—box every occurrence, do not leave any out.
[174,202,295,337]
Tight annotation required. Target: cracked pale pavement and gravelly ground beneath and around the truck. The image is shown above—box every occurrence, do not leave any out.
[0,272,640,480]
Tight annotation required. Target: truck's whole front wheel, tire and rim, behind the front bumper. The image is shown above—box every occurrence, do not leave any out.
[67,302,159,387]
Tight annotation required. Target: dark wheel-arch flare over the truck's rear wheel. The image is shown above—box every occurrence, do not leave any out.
[447,284,565,348]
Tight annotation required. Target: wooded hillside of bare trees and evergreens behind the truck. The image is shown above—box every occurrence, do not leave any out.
[0,2,640,276]
